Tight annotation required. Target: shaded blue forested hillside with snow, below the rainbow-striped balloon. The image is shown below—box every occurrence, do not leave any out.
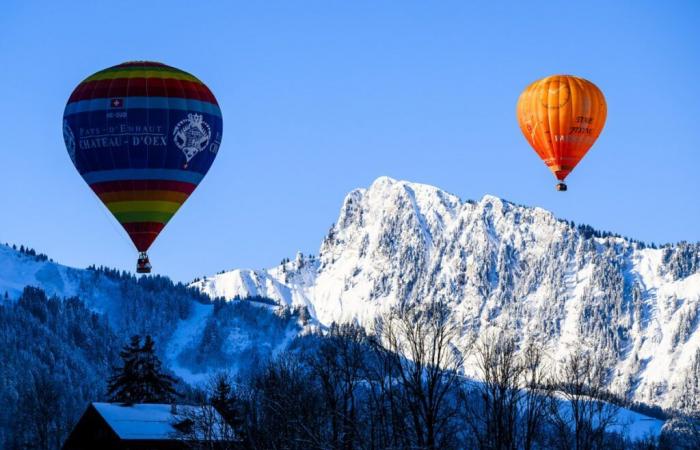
[0,245,304,448]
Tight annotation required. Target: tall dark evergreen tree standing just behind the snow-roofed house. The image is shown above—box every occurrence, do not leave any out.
[107,336,176,403]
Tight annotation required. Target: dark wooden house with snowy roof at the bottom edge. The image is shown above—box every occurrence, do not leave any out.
[62,403,234,450]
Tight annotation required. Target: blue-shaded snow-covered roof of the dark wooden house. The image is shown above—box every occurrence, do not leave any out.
[92,403,223,440]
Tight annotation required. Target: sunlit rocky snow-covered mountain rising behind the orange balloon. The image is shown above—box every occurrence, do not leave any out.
[193,177,700,407]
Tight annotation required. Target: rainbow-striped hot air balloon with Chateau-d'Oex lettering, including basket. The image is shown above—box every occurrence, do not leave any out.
[63,61,223,273]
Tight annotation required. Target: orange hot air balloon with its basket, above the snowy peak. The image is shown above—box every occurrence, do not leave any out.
[517,75,608,191]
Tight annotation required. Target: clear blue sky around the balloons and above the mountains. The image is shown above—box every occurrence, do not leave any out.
[0,0,700,280]
